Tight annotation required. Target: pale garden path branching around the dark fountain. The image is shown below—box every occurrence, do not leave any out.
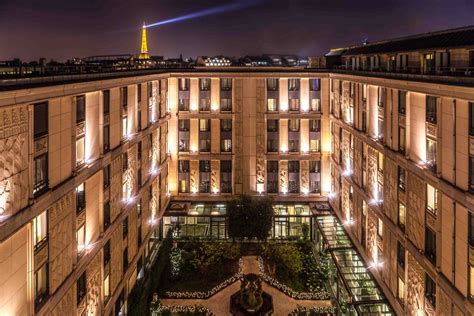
[161,256,331,316]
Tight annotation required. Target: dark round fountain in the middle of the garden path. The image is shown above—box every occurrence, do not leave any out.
[230,273,273,316]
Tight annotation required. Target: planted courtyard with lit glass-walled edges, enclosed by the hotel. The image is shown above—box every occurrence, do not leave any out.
[129,202,393,315]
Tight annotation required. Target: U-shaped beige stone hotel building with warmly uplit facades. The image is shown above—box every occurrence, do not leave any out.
[0,28,474,315]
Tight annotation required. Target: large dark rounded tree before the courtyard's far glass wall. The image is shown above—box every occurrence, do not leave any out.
[227,195,274,240]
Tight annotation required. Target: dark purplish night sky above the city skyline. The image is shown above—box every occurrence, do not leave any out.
[0,0,474,61]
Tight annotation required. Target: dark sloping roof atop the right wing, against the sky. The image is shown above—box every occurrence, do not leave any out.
[343,26,474,56]
